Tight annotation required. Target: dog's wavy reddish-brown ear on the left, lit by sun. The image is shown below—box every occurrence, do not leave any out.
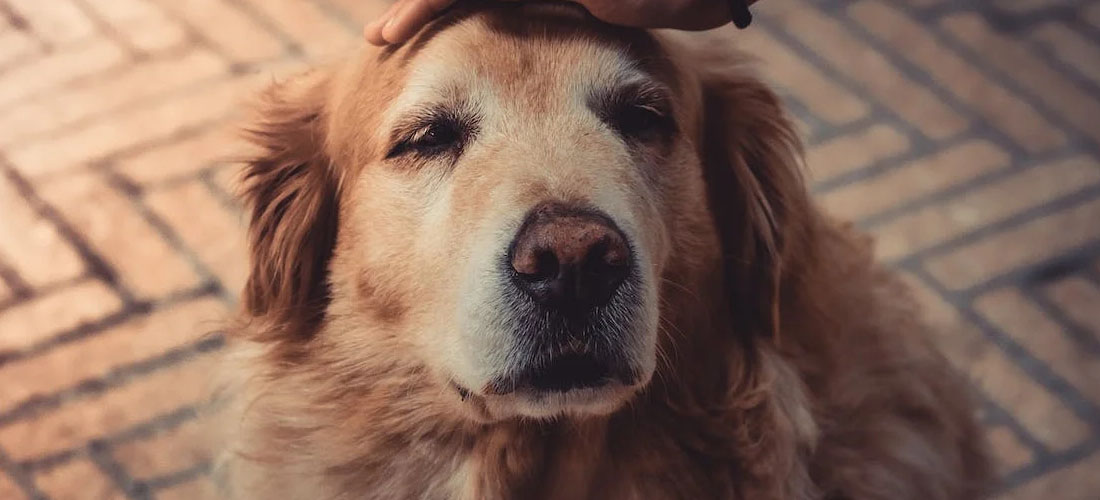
[243,75,339,341]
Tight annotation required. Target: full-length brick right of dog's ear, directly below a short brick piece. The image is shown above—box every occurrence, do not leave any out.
[821,141,1010,219]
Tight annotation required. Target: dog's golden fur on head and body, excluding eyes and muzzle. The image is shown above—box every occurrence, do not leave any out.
[218,5,989,500]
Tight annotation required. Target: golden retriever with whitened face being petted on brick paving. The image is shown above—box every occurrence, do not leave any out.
[217,2,989,500]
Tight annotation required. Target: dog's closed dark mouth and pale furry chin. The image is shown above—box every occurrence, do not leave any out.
[451,294,657,421]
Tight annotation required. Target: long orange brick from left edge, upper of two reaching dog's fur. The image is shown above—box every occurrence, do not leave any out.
[0,299,226,415]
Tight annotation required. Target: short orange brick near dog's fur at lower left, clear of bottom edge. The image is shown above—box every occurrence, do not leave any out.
[113,419,213,480]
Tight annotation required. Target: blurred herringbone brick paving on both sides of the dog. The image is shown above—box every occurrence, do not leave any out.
[0,0,1100,500]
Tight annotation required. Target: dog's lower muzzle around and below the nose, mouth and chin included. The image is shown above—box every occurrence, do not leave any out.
[452,243,657,420]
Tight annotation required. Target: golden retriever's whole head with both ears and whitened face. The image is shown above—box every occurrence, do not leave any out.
[244,4,804,419]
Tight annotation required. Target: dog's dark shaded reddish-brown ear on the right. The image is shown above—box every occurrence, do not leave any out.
[700,59,811,338]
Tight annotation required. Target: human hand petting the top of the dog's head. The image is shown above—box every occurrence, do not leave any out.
[363,0,755,45]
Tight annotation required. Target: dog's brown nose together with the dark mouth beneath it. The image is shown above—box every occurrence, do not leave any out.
[488,203,639,393]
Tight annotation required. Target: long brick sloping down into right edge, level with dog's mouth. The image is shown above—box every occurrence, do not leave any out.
[975,289,1100,402]
